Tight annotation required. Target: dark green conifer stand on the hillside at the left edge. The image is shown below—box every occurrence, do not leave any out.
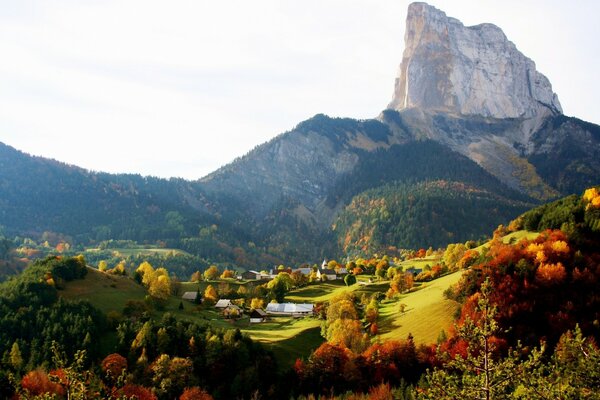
[0,258,106,368]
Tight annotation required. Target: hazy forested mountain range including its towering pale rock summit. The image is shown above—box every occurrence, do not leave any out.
[0,3,600,266]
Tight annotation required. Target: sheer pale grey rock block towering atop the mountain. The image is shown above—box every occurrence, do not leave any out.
[388,3,562,119]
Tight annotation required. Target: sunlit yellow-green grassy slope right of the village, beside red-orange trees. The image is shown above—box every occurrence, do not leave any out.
[378,271,462,343]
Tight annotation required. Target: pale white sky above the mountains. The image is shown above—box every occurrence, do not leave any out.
[0,0,600,179]
